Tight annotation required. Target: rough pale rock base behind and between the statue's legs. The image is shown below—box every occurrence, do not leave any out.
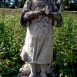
[17,63,55,77]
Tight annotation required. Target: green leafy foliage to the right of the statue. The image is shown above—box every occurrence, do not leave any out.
[54,13,77,77]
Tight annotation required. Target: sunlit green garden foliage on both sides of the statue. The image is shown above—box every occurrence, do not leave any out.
[0,8,77,77]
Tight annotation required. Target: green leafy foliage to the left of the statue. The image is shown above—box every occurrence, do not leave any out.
[0,12,26,77]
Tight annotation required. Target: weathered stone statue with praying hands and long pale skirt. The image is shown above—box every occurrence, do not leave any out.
[20,0,62,77]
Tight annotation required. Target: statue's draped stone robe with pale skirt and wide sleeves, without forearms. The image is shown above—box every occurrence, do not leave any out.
[20,0,62,64]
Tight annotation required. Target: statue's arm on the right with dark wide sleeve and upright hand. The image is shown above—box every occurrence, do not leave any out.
[44,5,63,27]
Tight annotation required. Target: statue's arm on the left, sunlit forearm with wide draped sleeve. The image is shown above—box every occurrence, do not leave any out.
[20,0,44,26]
